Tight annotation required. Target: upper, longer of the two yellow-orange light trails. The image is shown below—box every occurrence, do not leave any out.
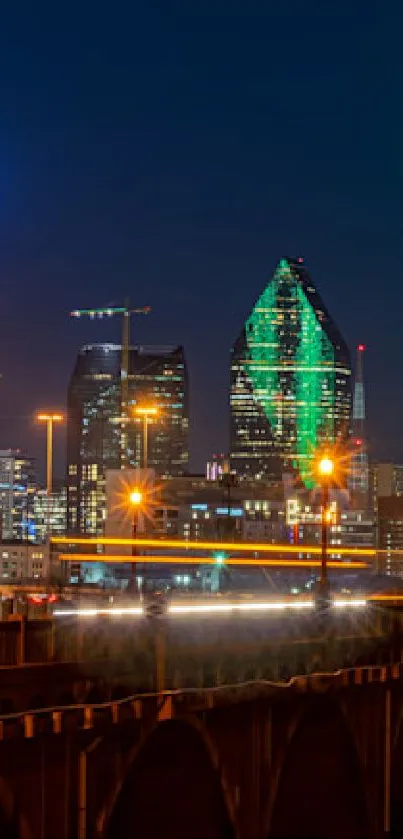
[51,536,376,557]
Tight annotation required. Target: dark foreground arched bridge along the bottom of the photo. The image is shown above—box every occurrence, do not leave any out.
[0,663,403,839]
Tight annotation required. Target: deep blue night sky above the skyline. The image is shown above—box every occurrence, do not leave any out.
[0,0,403,474]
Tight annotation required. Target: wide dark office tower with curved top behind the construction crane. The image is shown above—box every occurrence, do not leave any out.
[67,344,189,534]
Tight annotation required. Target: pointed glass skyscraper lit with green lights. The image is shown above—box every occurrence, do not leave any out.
[230,258,351,487]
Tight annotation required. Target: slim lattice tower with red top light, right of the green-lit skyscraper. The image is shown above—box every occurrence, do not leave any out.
[349,344,369,509]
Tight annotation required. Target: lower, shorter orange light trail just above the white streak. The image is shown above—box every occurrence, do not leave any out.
[59,553,369,571]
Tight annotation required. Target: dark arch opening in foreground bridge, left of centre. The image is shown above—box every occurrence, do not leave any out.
[97,720,237,839]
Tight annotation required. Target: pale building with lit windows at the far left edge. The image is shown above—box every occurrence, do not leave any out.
[0,449,35,541]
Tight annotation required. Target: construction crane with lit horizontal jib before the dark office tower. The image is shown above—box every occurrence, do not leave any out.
[70,300,151,469]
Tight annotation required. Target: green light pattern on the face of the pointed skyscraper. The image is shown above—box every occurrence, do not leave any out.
[244,260,342,487]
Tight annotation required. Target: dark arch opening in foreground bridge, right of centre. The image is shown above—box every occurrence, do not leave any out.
[265,697,372,839]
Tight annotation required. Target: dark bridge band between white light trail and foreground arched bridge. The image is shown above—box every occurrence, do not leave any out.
[0,599,403,713]
